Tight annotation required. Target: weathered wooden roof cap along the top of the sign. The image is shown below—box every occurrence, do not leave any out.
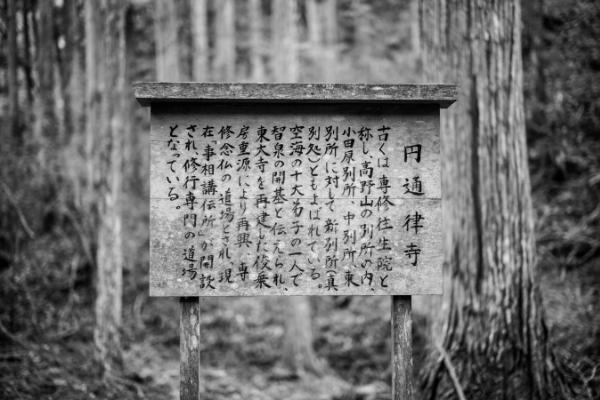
[133,82,457,108]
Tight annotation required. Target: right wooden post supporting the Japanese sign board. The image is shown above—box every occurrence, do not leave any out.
[392,296,413,400]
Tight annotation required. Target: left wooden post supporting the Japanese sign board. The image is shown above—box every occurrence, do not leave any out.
[179,297,200,400]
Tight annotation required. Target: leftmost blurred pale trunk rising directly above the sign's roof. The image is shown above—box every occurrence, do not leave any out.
[154,0,182,82]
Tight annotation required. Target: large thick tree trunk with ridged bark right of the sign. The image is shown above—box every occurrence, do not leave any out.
[419,0,558,399]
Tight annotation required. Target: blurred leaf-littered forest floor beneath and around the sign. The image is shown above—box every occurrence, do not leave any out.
[0,253,600,400]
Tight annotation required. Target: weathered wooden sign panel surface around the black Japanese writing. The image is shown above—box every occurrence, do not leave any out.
[150,104,442,296]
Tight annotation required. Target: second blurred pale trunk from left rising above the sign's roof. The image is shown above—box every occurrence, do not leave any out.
[190,0,208,82]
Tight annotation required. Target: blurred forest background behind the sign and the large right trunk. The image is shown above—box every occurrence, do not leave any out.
[0,0,600,399]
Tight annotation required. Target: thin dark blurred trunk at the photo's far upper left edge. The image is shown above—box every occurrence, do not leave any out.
[3,0,19,140]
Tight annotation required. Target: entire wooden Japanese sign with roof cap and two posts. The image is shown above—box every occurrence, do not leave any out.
[134,83,456,400]
